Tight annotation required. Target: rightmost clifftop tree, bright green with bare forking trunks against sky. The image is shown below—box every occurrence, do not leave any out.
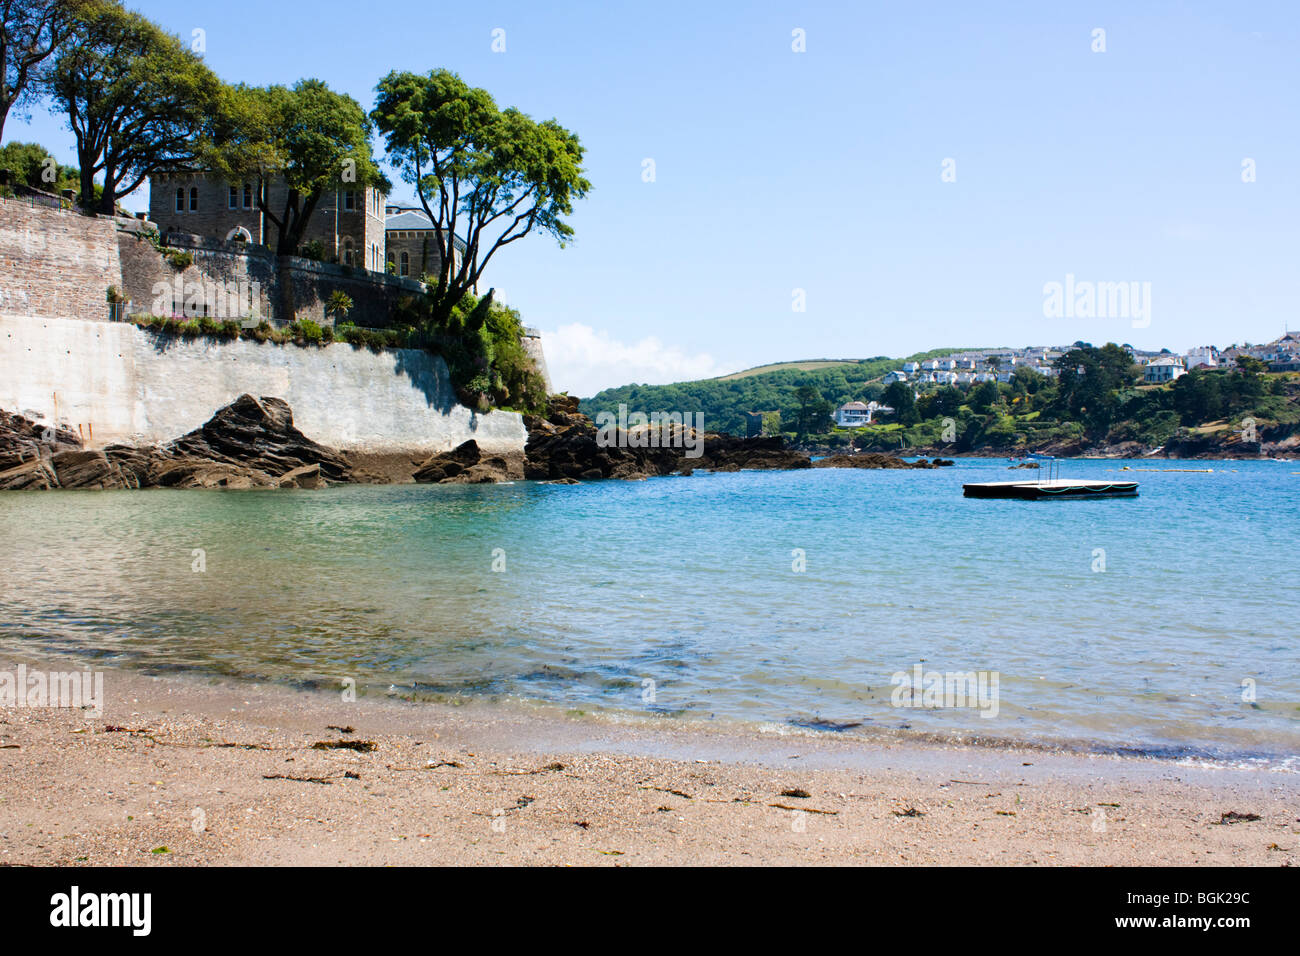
[371,70,592,325]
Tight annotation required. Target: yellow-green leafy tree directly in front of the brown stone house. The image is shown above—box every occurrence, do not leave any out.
[204,79,390,255]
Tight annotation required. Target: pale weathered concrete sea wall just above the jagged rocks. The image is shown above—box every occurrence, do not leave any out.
[0,316,528,453]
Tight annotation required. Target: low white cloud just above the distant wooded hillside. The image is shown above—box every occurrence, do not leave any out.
[542,323,727,398]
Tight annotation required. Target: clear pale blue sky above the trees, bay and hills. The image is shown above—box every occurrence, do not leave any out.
[7,0,1300,394]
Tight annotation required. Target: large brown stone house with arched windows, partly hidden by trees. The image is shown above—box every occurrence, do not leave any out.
[150,173,386,272]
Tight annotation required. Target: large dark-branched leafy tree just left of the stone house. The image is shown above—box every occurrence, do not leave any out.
[49,0,222,213]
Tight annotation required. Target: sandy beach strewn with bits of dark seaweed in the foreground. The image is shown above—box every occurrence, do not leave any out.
[0,671,1300,866]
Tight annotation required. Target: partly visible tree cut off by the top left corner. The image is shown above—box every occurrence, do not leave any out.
[0,0,83,140]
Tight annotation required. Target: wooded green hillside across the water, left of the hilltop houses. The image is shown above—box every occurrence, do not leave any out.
[581,349,965,434]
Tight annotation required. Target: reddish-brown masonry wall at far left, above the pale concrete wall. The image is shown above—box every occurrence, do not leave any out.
[0,198,122,319]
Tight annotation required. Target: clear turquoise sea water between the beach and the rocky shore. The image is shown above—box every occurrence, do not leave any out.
[0,459,1300,769]
